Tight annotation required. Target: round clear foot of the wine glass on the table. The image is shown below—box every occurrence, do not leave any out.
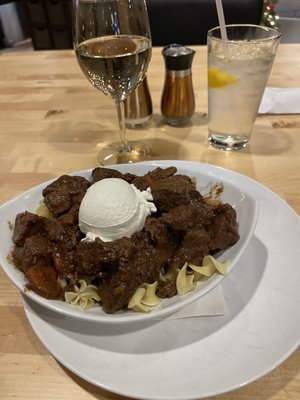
[98,142,150,165]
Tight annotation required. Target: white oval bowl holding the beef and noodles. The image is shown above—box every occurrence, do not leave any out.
[0,161,258,324]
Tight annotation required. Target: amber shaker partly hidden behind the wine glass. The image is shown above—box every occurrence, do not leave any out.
[125,76,152,129]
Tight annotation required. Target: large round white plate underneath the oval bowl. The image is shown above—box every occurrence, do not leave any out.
[24,167,300,400]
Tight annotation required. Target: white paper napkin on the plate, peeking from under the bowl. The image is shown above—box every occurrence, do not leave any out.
[159,285,226,320]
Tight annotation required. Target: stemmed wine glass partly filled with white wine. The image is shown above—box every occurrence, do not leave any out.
[73,0,151,165]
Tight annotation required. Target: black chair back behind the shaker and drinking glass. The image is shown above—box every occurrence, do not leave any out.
[146,0,263,46]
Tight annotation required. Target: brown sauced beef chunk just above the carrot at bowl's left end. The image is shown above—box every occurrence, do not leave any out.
[12,235,53,273]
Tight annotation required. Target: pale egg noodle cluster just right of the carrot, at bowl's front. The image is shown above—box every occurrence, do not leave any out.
[65,279,101,310]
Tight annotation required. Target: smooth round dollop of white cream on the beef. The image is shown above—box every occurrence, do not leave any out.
[78,178,156,242]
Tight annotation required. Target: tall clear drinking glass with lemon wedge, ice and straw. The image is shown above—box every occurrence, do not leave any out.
[207,24,281,150]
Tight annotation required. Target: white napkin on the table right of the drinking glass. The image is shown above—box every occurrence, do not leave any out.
[258,87,300,114]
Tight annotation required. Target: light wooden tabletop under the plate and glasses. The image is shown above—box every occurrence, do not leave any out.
[0,45,300,400]
